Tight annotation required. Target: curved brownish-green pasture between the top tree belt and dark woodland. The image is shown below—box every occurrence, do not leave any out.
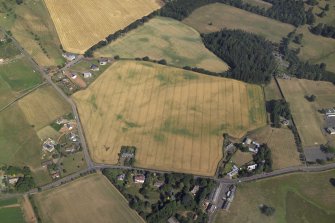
[183,3,294,43]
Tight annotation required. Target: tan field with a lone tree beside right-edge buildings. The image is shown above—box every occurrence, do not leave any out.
[279,79,335,147]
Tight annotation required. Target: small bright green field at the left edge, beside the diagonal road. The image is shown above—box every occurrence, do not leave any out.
[0,58,41,92]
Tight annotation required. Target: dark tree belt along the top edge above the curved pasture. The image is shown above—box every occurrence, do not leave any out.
[159,0,315,26]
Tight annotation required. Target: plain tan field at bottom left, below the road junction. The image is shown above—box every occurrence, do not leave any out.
[33,174,144,223]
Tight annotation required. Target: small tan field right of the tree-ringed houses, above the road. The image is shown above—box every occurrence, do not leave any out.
[250,126,301,169]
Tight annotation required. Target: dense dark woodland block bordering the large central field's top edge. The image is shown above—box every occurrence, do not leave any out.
[202,29,276,83]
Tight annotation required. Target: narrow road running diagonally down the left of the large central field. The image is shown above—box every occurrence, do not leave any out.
[0,28,94,168]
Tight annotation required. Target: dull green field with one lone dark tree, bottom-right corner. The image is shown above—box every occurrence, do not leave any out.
[215,171,335,223]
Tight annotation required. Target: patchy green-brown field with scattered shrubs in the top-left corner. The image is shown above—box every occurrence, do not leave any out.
[0,0,64,66]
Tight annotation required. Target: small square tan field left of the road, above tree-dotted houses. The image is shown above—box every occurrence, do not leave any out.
[19,86,71,130]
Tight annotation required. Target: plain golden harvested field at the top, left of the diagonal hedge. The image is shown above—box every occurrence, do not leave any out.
[45,0,160,53]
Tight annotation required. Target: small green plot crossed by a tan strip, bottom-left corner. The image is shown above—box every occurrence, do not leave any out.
[0,198,25,223]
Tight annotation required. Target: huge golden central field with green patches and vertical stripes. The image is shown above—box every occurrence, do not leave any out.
[73,61,266,175]
